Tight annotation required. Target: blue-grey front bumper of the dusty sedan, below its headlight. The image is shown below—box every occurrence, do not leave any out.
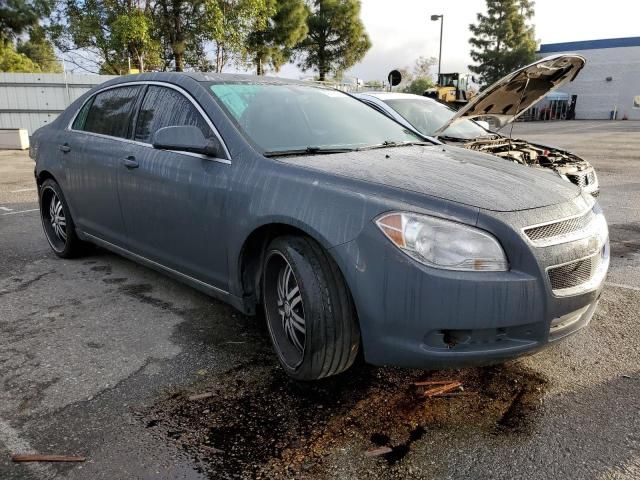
[332,197,604,368]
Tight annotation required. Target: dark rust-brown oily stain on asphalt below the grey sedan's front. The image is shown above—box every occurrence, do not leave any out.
[140,348,546,479]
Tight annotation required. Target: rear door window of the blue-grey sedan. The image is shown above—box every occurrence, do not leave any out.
[80,85,141,138]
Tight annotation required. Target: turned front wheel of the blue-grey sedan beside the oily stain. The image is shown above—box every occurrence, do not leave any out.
[262,236,360,380]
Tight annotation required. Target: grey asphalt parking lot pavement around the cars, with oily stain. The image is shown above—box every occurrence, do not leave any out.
[0,121,640,480]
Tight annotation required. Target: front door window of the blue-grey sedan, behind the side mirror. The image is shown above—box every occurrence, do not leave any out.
[135,85,213,143]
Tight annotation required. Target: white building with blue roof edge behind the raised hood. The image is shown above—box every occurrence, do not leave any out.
[539,37,640,120]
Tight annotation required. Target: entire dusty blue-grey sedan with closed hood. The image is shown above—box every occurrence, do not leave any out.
[31,73,609,380]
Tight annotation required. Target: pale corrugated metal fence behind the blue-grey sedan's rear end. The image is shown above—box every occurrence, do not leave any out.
[0,73,114,135]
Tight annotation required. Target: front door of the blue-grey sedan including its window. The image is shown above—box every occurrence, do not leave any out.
[118,84,231,290]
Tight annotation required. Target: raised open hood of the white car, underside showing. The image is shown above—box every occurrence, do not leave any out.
[434,54,586,136]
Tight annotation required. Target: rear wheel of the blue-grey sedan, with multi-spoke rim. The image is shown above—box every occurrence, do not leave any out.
[40,179,82,258]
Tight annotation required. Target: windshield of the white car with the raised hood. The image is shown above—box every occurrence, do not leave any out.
[383,96,490,140]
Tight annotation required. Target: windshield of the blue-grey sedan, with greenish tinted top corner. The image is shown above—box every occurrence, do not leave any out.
[209,82,424,155]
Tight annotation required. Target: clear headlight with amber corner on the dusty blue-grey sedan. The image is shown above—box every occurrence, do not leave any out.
[376,212,509,272]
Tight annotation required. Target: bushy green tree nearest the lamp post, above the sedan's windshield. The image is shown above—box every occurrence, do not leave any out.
[299,0,371,81]
